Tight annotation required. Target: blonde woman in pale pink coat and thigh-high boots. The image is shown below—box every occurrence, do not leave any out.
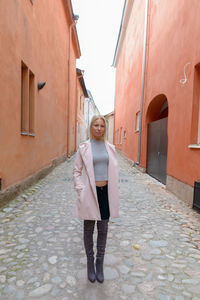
[73,115,118,283]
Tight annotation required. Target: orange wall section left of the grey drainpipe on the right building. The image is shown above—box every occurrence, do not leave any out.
[115,1,145,161]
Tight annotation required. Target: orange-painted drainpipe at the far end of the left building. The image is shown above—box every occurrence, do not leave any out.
[67,21,77,157]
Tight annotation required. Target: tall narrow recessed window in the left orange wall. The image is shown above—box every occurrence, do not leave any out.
[21,62,35,136]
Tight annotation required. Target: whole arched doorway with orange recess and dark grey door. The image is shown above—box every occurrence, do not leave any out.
[147,94,168,184]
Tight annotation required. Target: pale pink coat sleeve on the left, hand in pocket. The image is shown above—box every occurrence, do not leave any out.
[73,149,84,192]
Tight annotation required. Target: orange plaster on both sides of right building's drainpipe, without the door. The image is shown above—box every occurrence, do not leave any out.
[115,0,200,185]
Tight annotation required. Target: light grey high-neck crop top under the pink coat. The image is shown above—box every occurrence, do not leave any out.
[91,139,109,181]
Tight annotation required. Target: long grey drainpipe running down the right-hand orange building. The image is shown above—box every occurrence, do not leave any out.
[136,0,149,165]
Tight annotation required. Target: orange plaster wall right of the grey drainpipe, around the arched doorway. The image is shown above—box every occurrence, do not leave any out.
[142,0,200,186]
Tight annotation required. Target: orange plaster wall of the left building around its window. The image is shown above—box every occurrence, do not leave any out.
[0,0,76,189]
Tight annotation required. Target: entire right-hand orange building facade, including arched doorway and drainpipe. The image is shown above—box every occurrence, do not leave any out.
[113,0,200,205]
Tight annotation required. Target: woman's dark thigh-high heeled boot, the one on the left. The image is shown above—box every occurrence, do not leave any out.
[83,220,96,282]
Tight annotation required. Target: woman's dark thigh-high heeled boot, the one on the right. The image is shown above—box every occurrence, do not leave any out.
[96,220,109,283]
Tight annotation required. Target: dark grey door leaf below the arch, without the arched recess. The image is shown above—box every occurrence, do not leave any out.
[147,118,168,184]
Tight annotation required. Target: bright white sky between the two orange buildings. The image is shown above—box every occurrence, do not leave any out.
[72,0,124,115]
